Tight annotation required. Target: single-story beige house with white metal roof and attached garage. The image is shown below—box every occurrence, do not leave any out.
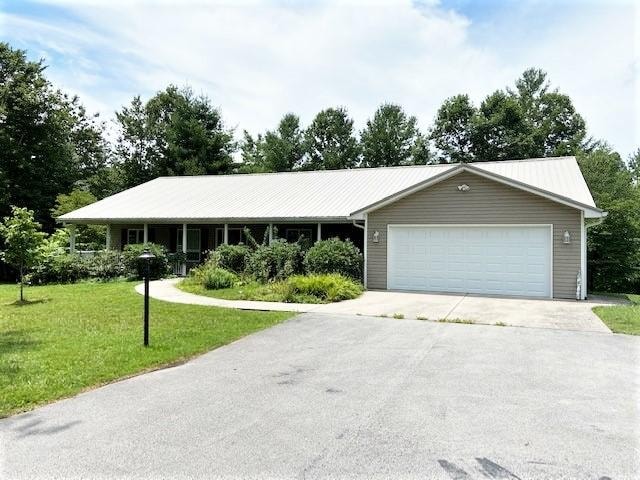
[59,157,606,299]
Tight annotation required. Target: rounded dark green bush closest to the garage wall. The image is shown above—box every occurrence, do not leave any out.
[304,238,364,280]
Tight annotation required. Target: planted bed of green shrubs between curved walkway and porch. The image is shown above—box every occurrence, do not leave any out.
[178,238,364,303]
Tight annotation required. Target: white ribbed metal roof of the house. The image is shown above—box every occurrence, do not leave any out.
[59,157,597,223]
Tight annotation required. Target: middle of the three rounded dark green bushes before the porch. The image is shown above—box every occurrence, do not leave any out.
[245,241,302,282]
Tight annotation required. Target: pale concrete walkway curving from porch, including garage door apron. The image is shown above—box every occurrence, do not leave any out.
[136,278,613,333]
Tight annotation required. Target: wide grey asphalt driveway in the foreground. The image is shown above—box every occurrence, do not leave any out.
[0,313,640,479]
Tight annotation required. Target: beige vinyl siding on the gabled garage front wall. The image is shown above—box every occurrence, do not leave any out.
[367,172,581,298]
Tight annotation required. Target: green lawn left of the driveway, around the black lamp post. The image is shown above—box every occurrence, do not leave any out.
[0,282,292,417]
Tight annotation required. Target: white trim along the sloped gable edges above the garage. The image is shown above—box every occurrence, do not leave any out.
[349,164,604,218]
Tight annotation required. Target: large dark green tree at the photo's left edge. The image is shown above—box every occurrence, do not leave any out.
[0,43,107,229]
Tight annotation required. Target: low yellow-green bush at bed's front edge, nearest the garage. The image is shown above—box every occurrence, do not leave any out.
[286,273,362,302]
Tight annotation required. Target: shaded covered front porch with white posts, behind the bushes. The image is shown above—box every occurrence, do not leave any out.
[70,221,364,275]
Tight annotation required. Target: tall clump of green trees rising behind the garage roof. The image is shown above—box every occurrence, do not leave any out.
[430,68,586,162]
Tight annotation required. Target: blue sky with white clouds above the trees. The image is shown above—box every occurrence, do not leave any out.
[0,0,640,156]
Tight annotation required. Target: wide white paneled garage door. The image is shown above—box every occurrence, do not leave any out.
[387,226,551,297]
